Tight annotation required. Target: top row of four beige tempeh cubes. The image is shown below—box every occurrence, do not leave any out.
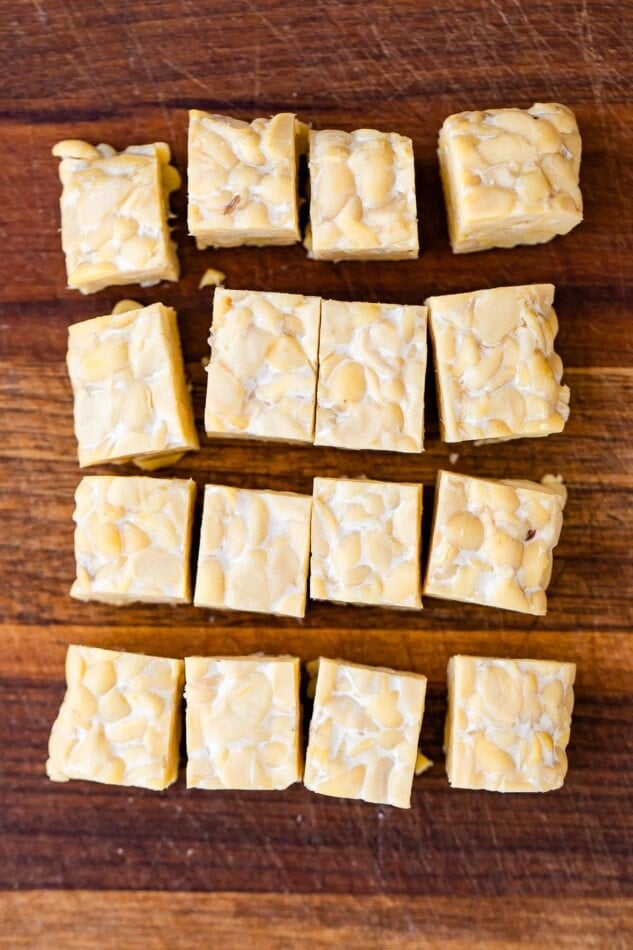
[53,103,582,293]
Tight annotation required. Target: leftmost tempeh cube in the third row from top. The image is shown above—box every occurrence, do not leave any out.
[70,475,196,605]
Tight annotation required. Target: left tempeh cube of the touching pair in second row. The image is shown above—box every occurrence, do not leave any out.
[204,290,321,442]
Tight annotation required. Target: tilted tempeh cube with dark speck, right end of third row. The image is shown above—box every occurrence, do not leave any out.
[424,471,563,615]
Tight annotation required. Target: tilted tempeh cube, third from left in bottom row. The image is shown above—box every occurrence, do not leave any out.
[304,658,426,808]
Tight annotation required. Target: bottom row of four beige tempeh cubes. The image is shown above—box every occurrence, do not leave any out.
[46,646,576,808]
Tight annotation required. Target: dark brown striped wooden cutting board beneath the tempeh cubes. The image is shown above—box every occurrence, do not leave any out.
[0,0,633,948]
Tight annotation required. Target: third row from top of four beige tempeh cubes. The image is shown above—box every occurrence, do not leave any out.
[71,471,564,617]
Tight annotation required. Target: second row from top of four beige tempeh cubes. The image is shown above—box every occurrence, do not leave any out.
[68,284,569,468]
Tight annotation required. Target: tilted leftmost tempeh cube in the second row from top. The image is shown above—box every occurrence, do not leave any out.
[66,303,199,468]
